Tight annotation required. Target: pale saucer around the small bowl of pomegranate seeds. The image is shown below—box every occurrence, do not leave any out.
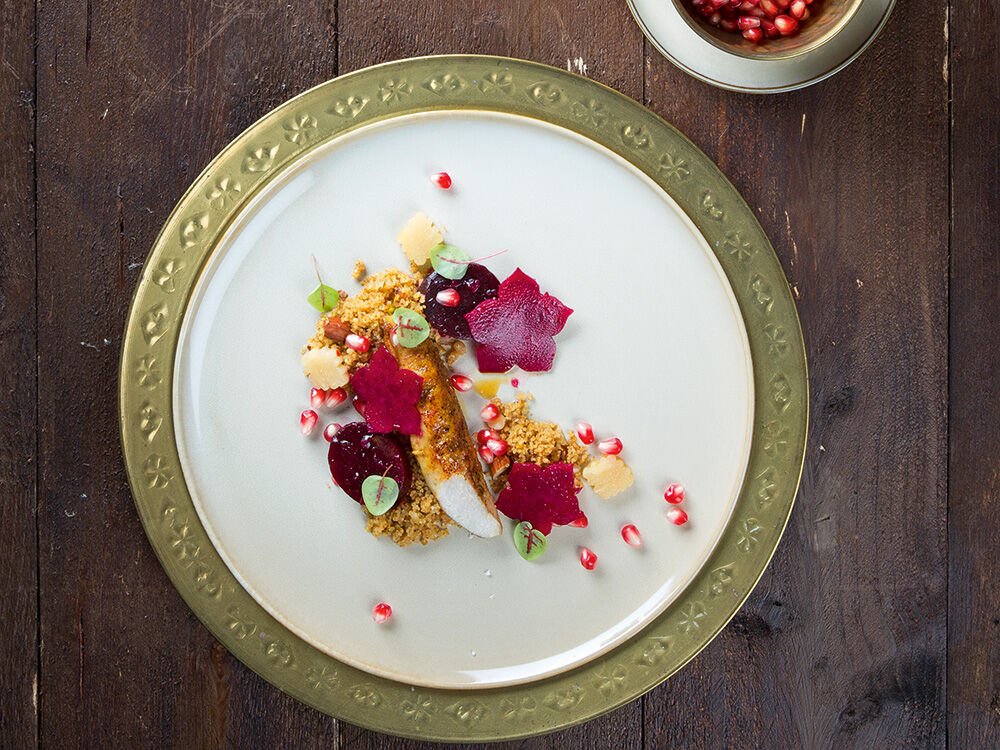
[628,0,895,93]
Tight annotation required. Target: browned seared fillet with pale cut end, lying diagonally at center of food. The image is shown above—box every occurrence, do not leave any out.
[385,332,503,537]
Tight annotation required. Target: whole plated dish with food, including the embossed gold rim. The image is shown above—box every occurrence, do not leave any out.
[122,57,807,739]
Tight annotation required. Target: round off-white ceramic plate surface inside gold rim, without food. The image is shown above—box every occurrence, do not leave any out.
[174,111,753,687]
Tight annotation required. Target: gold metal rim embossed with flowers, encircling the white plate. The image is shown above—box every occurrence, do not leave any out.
[119,55,809,742]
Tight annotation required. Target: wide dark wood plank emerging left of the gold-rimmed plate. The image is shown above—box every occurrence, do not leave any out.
[35,0,337,747]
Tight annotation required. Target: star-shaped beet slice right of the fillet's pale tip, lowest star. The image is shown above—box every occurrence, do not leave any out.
[497,463,583,534]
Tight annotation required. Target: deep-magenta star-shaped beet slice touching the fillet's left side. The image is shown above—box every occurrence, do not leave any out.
[351,346,424,435]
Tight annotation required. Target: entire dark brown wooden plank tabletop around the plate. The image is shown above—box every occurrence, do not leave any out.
[0,0,1000,748]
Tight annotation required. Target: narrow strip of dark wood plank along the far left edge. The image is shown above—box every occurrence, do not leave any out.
[0,0,38,747]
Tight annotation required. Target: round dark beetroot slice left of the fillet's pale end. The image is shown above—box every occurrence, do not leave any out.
[328,422,413,504]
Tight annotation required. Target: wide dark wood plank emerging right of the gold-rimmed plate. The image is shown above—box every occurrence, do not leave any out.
[646,0,952,747]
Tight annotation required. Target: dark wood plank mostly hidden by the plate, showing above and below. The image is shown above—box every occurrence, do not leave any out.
[338,0,642,748]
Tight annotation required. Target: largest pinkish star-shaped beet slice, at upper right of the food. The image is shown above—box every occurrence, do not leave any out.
[465,268,573,372]
